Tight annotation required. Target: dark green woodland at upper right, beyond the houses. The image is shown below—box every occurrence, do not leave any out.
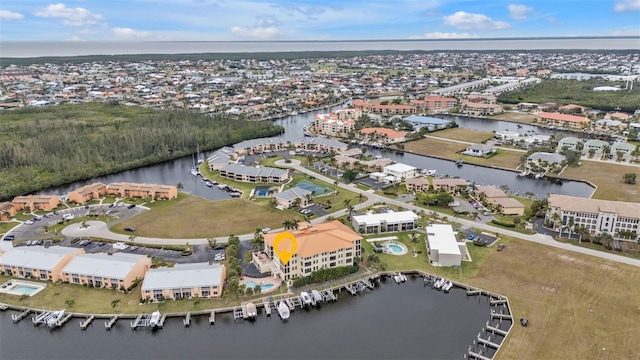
[498,79,640,113]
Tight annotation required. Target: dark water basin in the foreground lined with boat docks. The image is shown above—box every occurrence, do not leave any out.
[0,278,490,359]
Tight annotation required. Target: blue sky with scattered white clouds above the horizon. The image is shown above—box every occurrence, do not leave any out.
[0,0,640,41]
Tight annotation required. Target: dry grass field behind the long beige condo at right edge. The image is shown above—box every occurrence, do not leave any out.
[561,161,640,202]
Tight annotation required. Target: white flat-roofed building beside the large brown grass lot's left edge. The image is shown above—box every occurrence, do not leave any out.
[425,224,467,266]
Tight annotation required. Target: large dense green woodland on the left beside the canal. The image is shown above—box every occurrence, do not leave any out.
[0,102,284,200]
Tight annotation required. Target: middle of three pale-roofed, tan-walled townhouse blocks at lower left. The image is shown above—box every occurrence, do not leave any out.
[62,253,151,290]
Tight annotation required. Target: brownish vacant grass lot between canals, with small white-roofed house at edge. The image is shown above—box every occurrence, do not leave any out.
[405,138,522,169]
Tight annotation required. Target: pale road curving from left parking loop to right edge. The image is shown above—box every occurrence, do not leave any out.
[53,160,640,267]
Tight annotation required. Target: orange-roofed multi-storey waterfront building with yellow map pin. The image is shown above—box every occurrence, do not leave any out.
[253,220,362,281]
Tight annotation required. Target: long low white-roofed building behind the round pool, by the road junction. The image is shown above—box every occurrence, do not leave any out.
[351,211,420,234]
